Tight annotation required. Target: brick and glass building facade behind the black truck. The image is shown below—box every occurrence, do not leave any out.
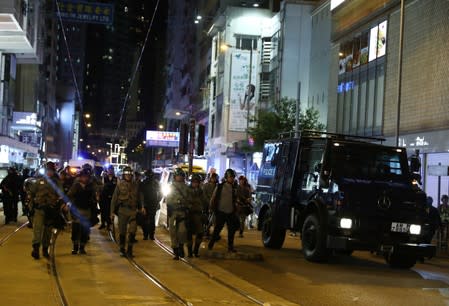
[328,0,449,203]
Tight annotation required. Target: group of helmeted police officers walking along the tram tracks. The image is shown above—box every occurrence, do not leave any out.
[22,162,248,260]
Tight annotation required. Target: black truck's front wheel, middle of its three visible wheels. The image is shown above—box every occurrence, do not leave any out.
[301,214,329,262]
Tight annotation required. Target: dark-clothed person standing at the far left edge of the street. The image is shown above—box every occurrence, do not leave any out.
[0,167,20,224]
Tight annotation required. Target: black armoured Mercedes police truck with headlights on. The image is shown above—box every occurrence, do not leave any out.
[256,131,435,268]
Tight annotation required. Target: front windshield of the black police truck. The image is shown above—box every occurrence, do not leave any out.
[331,143,407,181]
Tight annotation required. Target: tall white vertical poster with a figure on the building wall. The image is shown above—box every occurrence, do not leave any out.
[229,50,259,132]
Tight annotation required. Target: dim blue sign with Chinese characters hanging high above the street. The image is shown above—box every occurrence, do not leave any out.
[56,0,114,25]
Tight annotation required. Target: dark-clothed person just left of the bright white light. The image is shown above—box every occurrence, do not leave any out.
[139,169,161,240]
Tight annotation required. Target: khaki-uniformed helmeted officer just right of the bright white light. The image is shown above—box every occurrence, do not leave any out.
[166,168,190,260]
